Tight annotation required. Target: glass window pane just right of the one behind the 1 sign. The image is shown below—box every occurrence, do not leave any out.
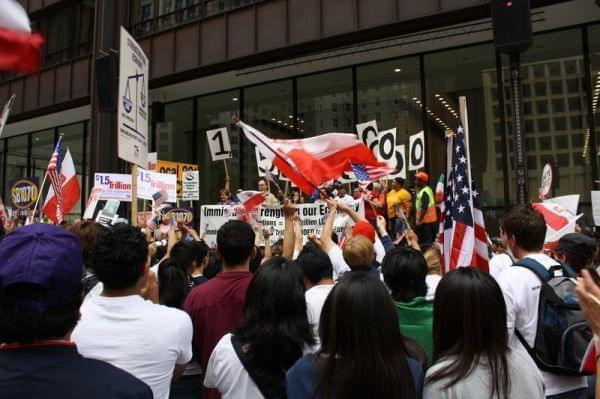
[241,79,292,191]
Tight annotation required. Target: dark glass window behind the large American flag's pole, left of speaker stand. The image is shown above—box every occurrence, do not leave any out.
[425,44,505,207]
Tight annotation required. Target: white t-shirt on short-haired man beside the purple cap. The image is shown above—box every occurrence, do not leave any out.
[71,295,193,399]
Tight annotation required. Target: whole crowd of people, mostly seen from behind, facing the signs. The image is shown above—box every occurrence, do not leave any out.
[0,176,600,399]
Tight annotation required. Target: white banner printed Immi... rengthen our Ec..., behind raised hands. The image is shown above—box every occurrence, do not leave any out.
[200,200,365,245]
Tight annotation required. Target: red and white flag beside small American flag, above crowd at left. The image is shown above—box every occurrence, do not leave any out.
[43,150,81,224]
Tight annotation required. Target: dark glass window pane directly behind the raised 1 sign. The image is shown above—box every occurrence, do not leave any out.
[197,90,239,204]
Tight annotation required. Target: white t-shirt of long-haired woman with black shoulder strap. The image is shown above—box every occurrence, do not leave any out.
[204,334,264,399]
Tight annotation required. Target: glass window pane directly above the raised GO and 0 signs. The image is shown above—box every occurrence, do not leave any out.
[356,57,423,177]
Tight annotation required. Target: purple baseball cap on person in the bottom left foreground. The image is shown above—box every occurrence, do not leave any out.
[0,223,85,311]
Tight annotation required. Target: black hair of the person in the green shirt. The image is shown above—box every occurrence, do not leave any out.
[381,247,427,302]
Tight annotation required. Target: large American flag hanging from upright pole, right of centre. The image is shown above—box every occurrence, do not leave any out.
[440,122,489,272]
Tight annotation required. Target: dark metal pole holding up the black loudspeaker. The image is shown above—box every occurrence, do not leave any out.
[510,53,529,204]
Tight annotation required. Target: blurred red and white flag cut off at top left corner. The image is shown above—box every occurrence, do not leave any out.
[0,0,44,72]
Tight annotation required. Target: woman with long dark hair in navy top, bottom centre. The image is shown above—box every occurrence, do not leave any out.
[287,272,423,399]
